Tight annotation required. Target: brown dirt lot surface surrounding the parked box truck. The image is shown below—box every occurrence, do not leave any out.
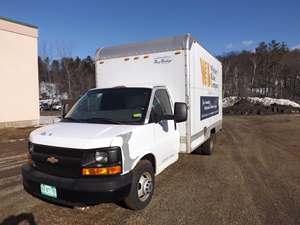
[0,115,300,225]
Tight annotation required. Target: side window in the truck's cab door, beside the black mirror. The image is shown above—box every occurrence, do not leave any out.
[149,89,172,123]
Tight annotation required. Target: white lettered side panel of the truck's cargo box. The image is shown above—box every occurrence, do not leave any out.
[190,43,222,150]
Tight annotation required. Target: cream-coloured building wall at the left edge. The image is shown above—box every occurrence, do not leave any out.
[0,18,39,127]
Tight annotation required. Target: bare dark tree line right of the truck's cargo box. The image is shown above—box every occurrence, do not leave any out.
[218,40,300,100]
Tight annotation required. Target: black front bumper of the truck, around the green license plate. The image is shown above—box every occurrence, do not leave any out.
[22,165,131,206]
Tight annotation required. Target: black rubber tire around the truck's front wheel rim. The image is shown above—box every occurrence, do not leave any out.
[124,160,155,210]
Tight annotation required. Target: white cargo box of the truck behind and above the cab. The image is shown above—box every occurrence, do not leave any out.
[95,35,222,153]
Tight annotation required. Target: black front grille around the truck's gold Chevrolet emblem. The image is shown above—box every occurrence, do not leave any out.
[32,145,83,178]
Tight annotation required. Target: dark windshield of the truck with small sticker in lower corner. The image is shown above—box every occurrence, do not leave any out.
[62,88,151,124]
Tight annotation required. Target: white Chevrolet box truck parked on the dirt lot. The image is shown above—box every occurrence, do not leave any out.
[22,35,222,209]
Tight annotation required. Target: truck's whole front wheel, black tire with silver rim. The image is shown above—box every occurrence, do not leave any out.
[124,160,155,210]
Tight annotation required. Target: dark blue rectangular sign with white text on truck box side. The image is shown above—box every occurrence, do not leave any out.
[200,96,219,120]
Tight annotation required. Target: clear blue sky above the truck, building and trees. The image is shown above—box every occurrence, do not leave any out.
[0,0,300,58]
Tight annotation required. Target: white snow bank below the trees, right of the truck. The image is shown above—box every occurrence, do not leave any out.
[223,96,300,108]
